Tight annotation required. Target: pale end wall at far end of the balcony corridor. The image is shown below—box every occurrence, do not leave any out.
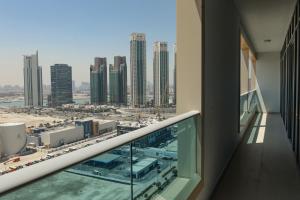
[256,52,280,113]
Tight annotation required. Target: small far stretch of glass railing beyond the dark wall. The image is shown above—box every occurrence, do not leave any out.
[240,90,258,132]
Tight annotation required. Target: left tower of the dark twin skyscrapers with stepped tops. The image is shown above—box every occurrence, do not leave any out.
[90,57,107,105]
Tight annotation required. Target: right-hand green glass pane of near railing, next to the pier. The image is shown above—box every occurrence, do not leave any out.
[132,118,197,199]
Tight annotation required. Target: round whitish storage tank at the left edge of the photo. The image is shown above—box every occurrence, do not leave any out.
[0,123,26,156]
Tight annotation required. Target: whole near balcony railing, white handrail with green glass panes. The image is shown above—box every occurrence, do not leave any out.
[0,111,201,200]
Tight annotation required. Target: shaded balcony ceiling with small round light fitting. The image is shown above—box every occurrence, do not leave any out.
[235,0,296,52]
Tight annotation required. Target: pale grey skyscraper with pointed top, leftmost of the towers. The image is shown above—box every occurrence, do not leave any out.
[23,52,43,106]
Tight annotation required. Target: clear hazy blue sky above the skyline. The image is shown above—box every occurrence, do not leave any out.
[0,0,176,86]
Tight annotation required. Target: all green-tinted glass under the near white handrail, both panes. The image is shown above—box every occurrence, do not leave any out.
[0,116,201,200]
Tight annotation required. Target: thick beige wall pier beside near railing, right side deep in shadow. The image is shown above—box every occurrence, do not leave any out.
[177,0,241,200]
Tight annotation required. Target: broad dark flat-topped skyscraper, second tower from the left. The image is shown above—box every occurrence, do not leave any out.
[51,64,73,106]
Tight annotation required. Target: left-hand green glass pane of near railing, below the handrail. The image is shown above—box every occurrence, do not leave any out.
[0,145,131,200]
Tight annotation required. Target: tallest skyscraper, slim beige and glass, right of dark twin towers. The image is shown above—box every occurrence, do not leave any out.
[130,33,146,107]
